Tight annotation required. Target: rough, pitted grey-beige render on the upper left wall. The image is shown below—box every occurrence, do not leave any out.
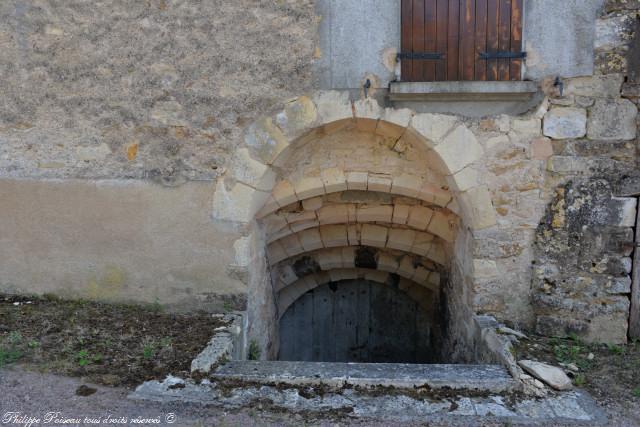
[0,0,317,185]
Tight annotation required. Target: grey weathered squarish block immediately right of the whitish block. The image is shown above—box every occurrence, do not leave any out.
[587,99,638,140]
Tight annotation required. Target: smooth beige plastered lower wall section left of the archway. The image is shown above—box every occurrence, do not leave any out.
[0,180,246,311]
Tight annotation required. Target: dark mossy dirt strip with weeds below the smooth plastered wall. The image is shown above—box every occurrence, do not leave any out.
[0,295,223,387]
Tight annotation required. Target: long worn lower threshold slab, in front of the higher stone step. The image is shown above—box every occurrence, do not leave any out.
[128,376,608,426]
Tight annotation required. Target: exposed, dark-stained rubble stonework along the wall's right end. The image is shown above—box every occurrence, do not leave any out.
[533,0,640,342]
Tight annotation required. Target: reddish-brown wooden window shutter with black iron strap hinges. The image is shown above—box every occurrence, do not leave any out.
[400,0,523,82]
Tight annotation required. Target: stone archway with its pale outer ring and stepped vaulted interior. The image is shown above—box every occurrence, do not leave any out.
[214,92,496,357]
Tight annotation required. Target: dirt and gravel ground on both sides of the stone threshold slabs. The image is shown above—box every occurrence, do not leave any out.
[0,295,640,426]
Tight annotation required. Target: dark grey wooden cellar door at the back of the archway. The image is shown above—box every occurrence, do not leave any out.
[279,280,433,363]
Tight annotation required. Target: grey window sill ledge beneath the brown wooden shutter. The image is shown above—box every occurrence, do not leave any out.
[389,81,538,102]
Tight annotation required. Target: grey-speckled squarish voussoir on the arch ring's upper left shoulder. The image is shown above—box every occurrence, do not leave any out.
[244,118,289,165]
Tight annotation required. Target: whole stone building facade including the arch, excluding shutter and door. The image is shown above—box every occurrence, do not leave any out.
[0,0,640,360]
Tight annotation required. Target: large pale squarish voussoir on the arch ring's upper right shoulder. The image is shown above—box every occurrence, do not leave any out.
[434,125,484,174]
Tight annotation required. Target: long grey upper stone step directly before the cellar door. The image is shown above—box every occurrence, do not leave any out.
[212,360,517,393]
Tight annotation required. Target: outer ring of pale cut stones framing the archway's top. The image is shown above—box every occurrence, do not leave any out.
[213,91,496,230]
